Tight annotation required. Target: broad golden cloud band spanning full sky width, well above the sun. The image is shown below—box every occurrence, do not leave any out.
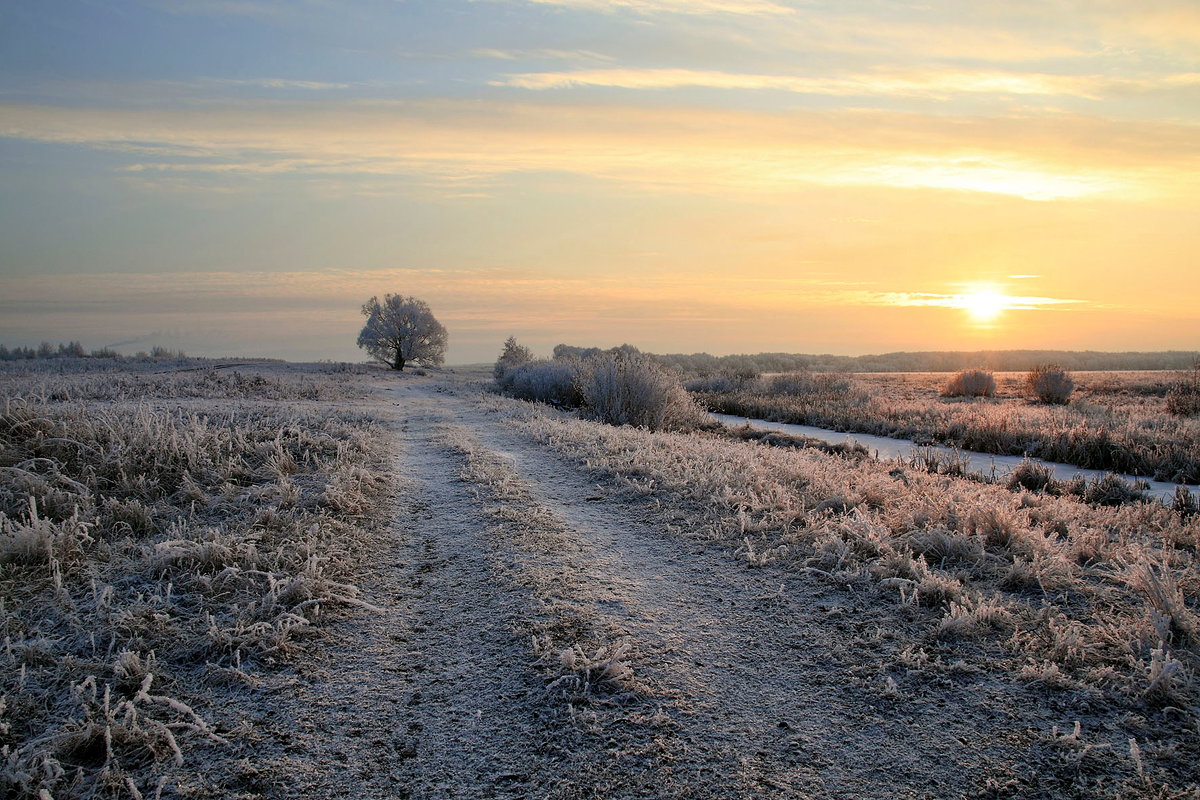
[0,100,1200,200]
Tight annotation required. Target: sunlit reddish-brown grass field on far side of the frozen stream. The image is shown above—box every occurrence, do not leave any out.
[690,372,1200,483]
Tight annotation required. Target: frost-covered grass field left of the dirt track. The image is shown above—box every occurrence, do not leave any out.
[0,359,388,798]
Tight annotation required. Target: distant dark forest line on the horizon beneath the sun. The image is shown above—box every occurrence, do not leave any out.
[554,344,1200,375]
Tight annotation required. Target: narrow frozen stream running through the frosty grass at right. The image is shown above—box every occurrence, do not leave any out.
[713,414,1200,503]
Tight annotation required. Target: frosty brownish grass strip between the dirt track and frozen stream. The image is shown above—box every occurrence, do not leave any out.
[480,388,1200,798]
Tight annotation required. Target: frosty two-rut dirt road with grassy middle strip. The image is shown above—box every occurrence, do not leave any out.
[223,378,1061,799]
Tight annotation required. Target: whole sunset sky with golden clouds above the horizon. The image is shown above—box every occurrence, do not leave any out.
[0,0,1200,363]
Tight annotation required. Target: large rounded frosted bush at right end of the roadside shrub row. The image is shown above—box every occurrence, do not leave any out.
[578,353,704,431]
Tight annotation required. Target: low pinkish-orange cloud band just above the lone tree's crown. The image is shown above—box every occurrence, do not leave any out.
[0,269,1084,321]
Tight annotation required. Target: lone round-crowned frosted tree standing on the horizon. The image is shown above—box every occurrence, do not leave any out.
[359,294,446,369]
